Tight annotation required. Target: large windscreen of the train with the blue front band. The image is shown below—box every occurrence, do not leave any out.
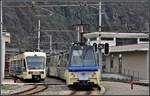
[70,47,96,66]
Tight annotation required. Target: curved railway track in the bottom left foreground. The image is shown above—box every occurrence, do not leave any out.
[10,84,48,96]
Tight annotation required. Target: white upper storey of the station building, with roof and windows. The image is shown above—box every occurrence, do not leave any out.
[84,32,148,46]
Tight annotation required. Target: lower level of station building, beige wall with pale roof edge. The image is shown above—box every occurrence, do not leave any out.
[103,43,149,80]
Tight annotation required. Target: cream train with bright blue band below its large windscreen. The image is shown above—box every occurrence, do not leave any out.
[48,43,101,86]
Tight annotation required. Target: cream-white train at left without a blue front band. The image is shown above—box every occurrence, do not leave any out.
[9,52,46,81]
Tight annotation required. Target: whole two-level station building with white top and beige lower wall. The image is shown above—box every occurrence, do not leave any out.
[84,32,149,80]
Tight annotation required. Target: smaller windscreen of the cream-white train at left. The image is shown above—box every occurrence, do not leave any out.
[26,56,45,69]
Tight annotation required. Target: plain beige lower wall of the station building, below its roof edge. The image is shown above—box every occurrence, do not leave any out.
[106,52,149,80]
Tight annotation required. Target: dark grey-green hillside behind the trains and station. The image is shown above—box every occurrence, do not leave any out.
[4,2,149,50]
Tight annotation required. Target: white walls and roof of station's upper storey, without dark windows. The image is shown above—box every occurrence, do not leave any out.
[84,32,148,46]
